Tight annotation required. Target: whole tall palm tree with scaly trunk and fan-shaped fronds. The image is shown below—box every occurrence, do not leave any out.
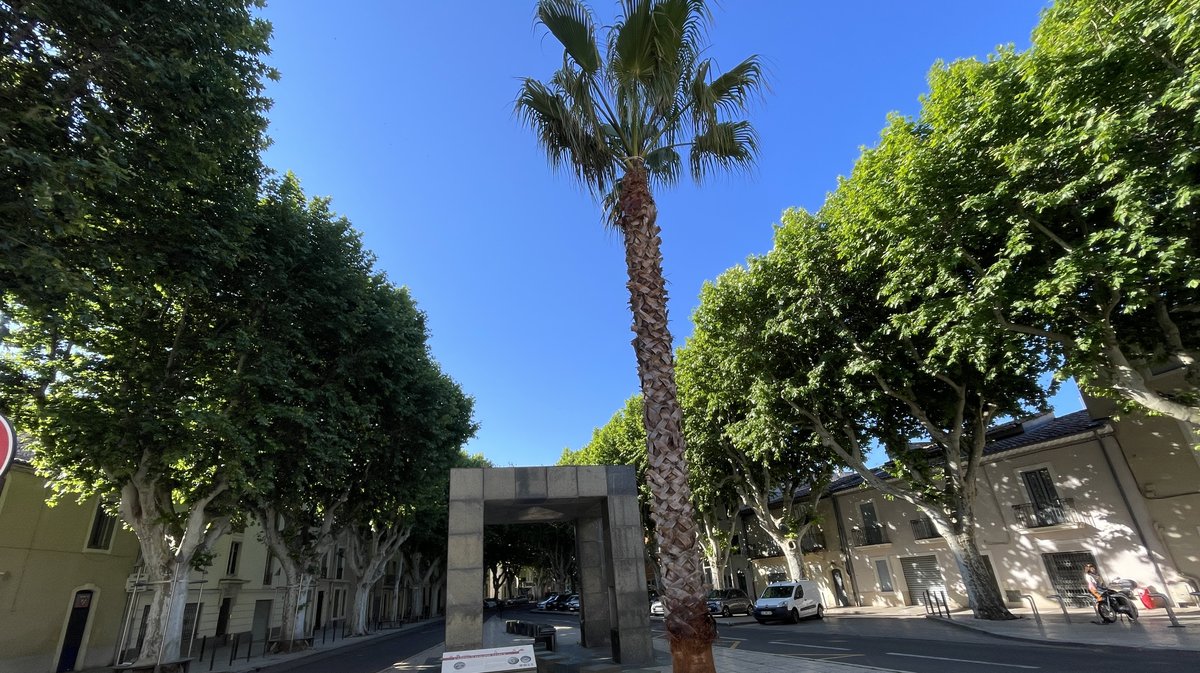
[516,0,763,673]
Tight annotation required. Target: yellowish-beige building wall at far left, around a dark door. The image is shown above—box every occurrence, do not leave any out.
[0,463,138,673]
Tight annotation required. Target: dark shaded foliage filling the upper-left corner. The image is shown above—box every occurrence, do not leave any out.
[0,0,274,312]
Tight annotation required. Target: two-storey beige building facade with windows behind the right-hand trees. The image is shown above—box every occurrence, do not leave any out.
[725,399,1200,609]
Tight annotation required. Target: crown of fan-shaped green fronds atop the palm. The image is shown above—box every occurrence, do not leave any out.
[516,0,763,223]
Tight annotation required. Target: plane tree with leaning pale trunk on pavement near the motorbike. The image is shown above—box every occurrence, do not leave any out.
[713,205,1048,619]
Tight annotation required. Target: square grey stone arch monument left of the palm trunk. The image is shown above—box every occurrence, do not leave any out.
[445,465,654,666]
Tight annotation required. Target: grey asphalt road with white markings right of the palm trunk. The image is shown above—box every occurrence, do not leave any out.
[672,617,1200,673]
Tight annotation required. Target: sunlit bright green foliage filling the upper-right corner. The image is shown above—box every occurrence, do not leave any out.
[852,0,1200,423]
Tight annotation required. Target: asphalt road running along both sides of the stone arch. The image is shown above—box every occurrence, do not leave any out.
[270,608,1198,673]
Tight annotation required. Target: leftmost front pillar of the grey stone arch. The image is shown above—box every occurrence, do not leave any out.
[445,468,484,651]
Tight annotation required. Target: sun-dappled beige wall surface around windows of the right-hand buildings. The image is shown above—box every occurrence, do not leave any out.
[734,401,1200,609]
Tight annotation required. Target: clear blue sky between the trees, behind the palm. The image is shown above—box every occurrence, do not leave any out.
[263,0,1081,465]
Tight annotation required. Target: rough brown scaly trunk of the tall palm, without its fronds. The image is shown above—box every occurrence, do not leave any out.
[619,158,716,673]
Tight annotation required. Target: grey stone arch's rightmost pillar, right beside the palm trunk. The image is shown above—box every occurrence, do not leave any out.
[606,465,654,666]
